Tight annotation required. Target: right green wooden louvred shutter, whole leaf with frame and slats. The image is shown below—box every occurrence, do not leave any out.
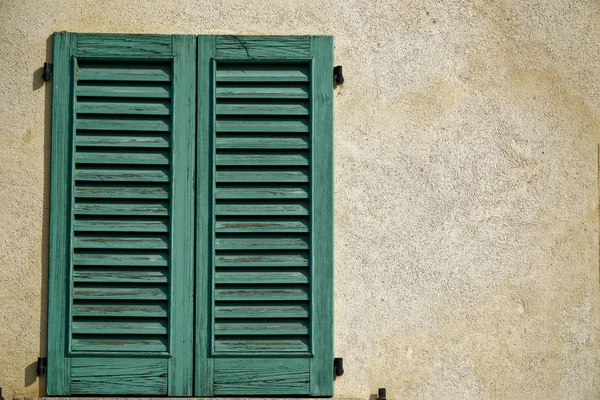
[195,36,333,396]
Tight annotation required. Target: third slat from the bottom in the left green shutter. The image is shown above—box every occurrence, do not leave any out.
[73,302,167,318]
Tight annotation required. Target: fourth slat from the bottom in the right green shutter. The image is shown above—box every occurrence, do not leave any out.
[215,286,308,301]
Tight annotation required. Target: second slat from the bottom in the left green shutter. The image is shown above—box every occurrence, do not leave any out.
[72,319,167,335]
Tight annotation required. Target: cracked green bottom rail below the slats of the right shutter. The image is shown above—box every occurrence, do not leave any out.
[214,358,310,396]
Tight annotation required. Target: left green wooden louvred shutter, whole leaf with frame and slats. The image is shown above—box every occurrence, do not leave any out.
[47,33,196,396]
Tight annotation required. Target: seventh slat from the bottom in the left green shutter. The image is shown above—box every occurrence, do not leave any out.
[73,234,169,249]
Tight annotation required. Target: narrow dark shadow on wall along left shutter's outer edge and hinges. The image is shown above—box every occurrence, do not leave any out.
[24,35,53,396]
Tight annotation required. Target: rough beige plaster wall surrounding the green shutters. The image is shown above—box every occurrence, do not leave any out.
[0,0,600,399]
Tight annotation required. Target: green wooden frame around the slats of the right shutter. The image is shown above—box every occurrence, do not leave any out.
[195,35,333,396]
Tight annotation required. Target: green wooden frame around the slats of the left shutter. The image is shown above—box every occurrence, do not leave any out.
[47,32,196,396]
